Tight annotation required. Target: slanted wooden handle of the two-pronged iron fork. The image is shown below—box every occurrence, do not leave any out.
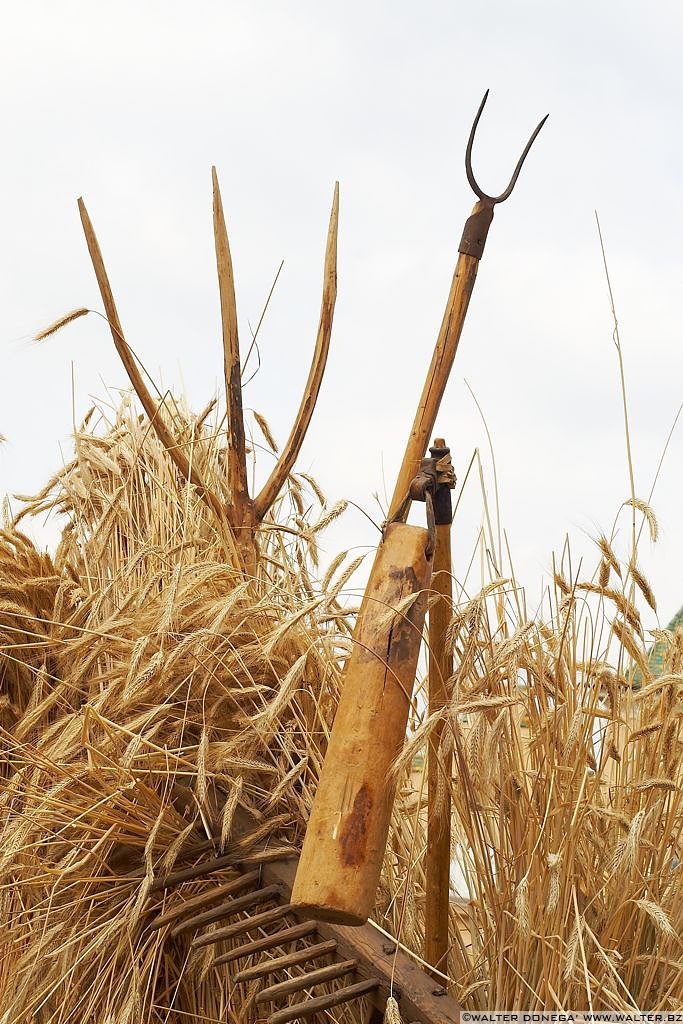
[388,233,479,519]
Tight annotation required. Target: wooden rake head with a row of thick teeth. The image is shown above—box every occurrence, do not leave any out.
[150,808,460,1024]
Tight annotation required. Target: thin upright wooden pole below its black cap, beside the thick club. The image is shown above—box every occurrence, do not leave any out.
[425,522,453,974]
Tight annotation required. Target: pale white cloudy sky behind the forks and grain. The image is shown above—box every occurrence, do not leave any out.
[0,0,683,622]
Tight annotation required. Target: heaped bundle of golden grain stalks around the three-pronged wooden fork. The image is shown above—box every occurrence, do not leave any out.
[0,397,421,1024]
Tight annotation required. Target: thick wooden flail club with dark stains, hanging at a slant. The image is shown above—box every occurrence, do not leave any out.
[292,523,431,925]
